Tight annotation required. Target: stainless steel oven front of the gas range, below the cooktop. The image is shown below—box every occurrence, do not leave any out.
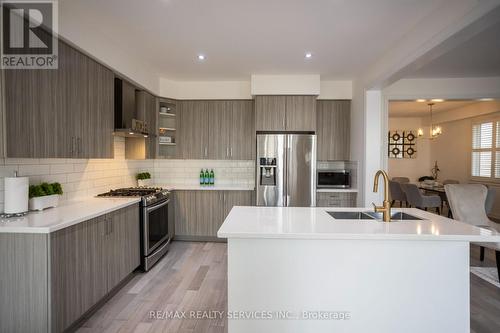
[141,198,172,271]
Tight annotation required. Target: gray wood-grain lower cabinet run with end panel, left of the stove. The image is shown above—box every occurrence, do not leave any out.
[0,204,140,332]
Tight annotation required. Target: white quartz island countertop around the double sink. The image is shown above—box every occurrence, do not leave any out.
[217,207,500,242]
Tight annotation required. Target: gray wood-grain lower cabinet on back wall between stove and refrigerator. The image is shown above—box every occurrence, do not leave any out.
[174,190,254,240]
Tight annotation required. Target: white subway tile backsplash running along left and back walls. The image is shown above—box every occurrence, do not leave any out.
[0,137,255,212]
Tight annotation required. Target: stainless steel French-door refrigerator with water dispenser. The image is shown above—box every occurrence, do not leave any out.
[256,134,316,207]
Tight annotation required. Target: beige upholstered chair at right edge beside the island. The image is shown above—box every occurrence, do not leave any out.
[444,184,500,279]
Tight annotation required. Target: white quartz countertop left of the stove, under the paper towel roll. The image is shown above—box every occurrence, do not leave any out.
[0,198,140,233]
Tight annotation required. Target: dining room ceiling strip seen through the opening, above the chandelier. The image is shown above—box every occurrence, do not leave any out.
[389,100,483,117]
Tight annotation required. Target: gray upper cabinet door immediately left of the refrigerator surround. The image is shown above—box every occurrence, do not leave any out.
[228,101,255,160]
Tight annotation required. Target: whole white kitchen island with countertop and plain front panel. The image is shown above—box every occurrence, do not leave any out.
[218,207,500,333]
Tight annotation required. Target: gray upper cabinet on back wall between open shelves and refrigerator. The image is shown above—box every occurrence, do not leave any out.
[177,100,255,160]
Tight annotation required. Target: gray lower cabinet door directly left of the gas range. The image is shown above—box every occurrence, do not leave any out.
[105,205,140,291]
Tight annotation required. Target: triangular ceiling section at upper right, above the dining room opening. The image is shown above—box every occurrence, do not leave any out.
[410,22,500,78]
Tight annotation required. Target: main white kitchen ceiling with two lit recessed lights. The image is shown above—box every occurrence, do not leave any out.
[59,0,442,80]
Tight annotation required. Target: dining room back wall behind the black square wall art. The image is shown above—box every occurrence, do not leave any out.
[387,117,432,182]
